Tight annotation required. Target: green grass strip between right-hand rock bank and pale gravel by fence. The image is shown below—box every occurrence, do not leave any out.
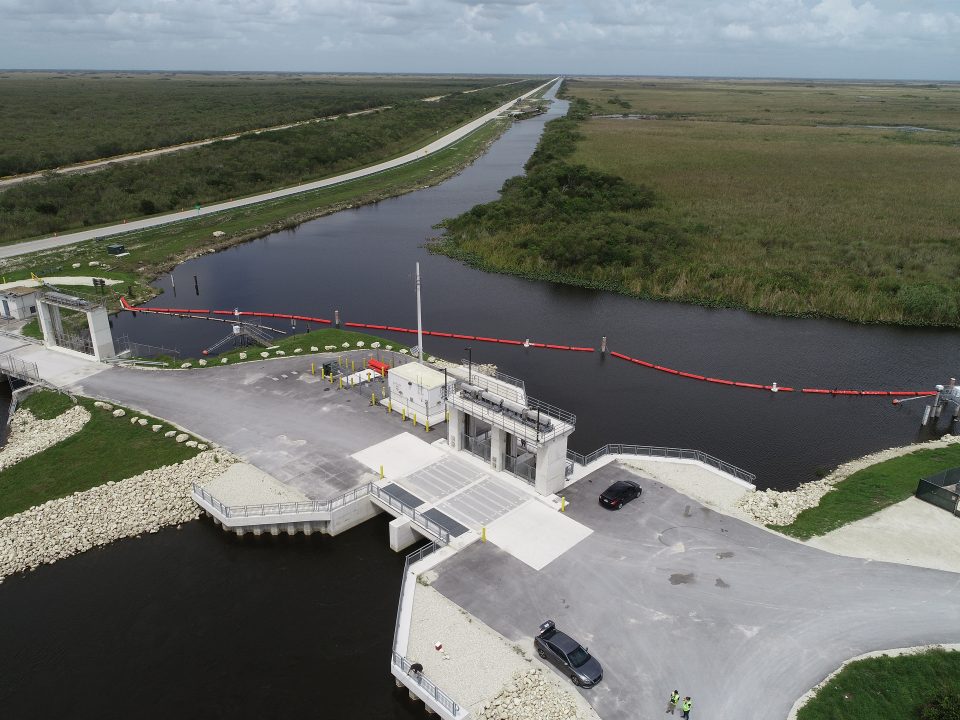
[784,445,960,540]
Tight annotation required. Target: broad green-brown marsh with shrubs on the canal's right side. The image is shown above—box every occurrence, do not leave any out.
[445,79,960,327]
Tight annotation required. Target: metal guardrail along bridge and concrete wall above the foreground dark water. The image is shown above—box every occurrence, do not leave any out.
[193,483,450,545]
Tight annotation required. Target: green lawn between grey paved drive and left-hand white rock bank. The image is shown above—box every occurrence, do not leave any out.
[0,390,198,517]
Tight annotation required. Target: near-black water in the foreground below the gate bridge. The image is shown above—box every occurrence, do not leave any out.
[0,518,423,720]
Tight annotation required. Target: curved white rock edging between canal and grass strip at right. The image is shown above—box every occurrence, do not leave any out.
[737,435,960,525]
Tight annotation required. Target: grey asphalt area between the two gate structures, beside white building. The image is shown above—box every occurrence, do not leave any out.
[71,355,420,500]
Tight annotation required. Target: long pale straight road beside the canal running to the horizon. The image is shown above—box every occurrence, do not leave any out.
[0,78,560,258]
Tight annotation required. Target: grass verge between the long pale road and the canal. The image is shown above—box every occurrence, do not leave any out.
[3,116,509,318]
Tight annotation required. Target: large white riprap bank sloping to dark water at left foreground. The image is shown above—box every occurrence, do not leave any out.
[0,450,236,580]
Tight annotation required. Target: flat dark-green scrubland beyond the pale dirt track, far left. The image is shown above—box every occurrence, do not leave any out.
[0,71,528,176]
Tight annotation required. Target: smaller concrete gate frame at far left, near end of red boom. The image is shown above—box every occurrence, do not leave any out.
[37,292,117,361]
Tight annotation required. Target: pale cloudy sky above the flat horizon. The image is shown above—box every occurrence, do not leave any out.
[0,0,960,80]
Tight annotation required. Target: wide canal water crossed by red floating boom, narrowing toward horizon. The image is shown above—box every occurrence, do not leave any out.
[114,86,960,489]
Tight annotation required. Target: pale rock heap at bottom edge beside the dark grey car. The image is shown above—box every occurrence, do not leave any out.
[477,669,587,720]
